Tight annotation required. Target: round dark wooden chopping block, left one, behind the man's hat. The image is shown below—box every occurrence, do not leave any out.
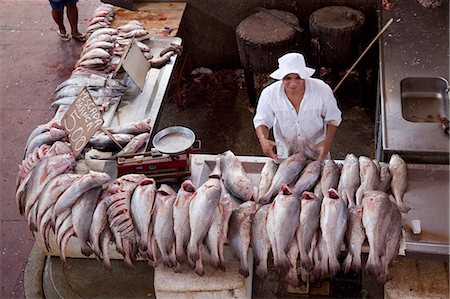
[236,9,298,107]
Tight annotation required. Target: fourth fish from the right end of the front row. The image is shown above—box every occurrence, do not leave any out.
[296,191,322,272]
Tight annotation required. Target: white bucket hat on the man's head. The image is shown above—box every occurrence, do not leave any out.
[270,53,316,80]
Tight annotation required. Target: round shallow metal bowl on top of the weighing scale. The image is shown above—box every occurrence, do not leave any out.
[152,126,195,155]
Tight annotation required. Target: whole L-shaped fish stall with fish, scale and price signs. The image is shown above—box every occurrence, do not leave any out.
[16,0,449,298]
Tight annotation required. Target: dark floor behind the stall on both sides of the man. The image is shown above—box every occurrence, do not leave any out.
[155,70,376,160]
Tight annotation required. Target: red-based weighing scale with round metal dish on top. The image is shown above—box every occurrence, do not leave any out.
[117,126,201,179]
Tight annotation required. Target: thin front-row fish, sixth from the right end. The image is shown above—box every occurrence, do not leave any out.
[251,205,270,278]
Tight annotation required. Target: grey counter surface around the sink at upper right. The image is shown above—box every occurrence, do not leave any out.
[379,0,449,164]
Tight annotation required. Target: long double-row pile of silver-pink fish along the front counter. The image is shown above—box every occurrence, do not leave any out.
[16,148,406,286]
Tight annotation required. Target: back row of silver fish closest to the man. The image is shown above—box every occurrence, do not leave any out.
[223,151,410,213]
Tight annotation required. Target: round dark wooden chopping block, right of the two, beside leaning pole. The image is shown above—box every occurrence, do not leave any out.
[309,6,365,65]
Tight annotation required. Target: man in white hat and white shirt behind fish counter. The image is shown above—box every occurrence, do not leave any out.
[253,53,342,161]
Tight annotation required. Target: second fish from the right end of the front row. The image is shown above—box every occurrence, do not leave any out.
[342,205,366,273]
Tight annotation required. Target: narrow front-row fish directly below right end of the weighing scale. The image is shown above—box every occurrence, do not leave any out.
[173,180,196,263]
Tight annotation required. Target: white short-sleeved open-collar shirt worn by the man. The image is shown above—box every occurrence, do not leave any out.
[253,78,342,158]
